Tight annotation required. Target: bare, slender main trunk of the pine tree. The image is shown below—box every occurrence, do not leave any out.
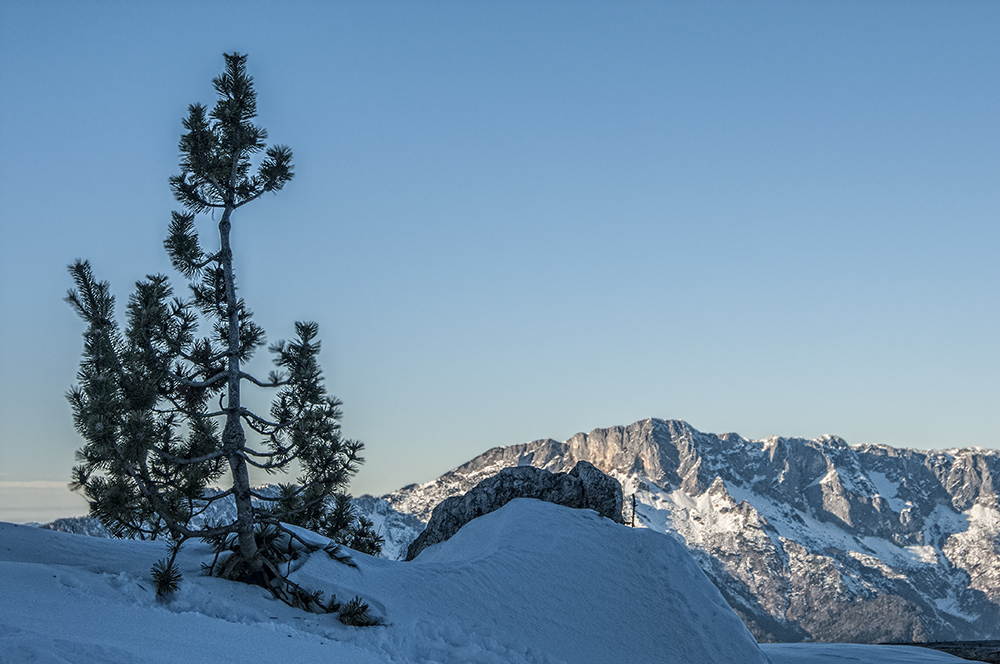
[219,205,264,581]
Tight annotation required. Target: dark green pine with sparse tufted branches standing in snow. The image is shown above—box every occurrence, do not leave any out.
[67,53,370,592]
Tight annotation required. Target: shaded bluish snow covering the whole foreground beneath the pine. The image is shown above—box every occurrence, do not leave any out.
[0,500,962,664]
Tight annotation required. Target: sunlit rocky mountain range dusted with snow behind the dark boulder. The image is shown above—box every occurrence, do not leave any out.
[356,419,1000,642]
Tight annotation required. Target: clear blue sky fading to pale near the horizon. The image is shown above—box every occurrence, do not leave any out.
[0,0,1000,521]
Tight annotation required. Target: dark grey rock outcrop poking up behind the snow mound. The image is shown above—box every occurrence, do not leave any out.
[406,461,622,560]
